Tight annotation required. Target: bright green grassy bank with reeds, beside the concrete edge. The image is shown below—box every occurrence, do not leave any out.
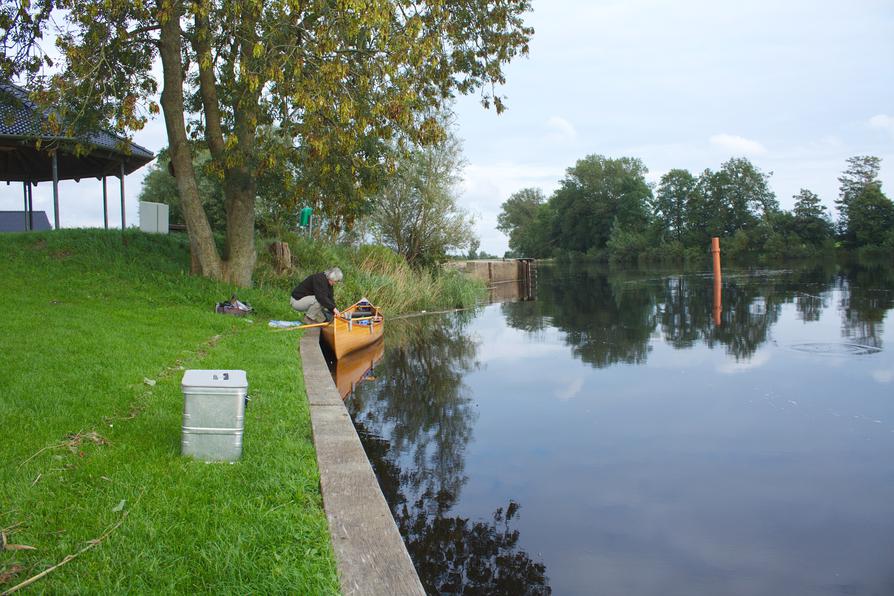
[0,230,484,594]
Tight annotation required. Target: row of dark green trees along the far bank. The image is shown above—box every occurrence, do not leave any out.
[497,155,894,261]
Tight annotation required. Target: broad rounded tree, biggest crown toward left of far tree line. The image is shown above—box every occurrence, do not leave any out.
[550,155,652,252]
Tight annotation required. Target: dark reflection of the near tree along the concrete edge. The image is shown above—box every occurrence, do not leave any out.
[347,313,549,594]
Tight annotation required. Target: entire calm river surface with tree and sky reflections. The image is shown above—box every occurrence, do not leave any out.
[347,265,894,596]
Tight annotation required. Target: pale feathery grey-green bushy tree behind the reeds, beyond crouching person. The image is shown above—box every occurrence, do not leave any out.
[370,135,475,267]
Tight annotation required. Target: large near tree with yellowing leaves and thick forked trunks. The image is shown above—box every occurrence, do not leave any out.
[0,0,533,285]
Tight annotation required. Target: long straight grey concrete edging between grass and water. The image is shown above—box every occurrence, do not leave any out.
[300,329,425,596]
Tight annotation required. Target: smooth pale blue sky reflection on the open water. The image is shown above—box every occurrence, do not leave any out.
[358,272,894,595]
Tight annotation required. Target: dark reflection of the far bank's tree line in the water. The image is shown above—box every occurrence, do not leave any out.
[502,262,894,367]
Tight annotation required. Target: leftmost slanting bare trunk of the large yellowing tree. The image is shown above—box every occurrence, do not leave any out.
[159,2,223,279]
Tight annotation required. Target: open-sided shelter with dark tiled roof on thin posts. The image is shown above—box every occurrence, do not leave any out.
[0,81,155,229]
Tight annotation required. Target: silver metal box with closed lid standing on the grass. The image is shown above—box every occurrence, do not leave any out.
[180,370,248,461]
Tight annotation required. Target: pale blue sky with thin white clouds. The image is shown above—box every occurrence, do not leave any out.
[0,0,894,256]
